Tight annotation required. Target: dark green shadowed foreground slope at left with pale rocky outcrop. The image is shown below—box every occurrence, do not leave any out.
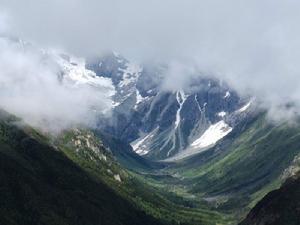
[0,107,236,225]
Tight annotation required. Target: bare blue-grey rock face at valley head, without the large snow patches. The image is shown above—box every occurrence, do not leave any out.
[87,54,247,159]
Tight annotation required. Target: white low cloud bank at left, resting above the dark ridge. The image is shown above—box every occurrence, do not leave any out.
[0,38,111,133]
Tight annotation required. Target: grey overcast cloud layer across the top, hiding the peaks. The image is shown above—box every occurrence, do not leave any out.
[0,0,300,121]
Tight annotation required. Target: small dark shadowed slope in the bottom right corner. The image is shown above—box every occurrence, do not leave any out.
[240,175,300,225]
